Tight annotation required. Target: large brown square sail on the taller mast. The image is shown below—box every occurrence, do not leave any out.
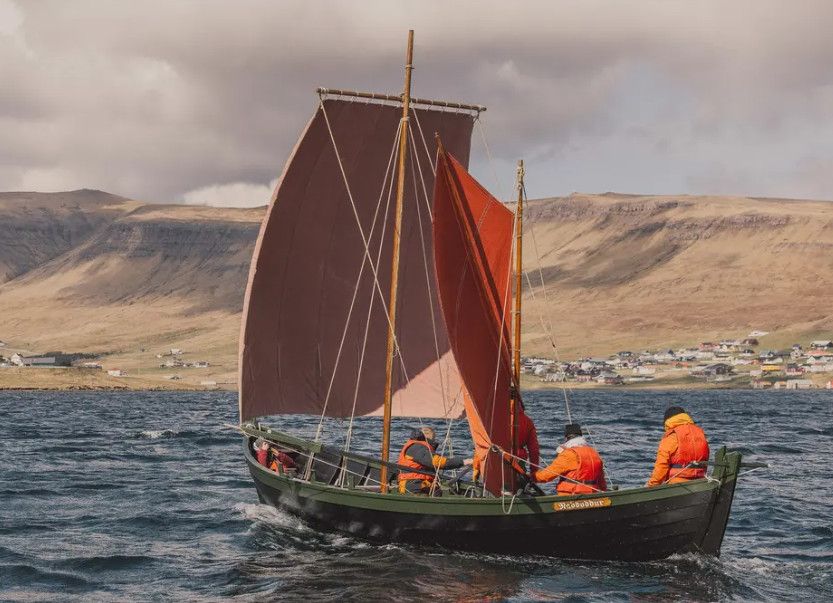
[239,98,473,420]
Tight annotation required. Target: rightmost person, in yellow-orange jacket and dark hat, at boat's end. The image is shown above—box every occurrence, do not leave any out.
[645,406,709,487]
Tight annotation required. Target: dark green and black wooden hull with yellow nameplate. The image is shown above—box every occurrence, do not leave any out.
[246,438,740,561]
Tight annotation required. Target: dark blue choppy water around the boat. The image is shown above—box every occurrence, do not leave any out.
[0,390,833,601]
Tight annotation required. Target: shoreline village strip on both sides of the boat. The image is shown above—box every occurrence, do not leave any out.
[0,331,833,390]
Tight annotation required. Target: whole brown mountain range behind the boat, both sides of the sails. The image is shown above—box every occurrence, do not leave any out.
[0,190,833,384]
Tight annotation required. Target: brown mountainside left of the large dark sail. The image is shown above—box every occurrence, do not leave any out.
[0,191,263,390]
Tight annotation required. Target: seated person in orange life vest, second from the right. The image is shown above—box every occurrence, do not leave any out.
[532,423,607,495]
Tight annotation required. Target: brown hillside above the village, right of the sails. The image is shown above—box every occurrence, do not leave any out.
[525,194,833,355]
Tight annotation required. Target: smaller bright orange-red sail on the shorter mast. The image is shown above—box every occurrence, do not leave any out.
[434,147,516,495]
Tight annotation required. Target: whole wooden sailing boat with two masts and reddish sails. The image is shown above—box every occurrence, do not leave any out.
[240,32,741,560]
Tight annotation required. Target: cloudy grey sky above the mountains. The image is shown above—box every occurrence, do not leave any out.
[0,0,833,205]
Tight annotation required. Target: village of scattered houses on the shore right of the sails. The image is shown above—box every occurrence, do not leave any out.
[521,331,833,390]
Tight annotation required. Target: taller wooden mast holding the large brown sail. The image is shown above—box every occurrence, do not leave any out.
[379,29,414,493]
